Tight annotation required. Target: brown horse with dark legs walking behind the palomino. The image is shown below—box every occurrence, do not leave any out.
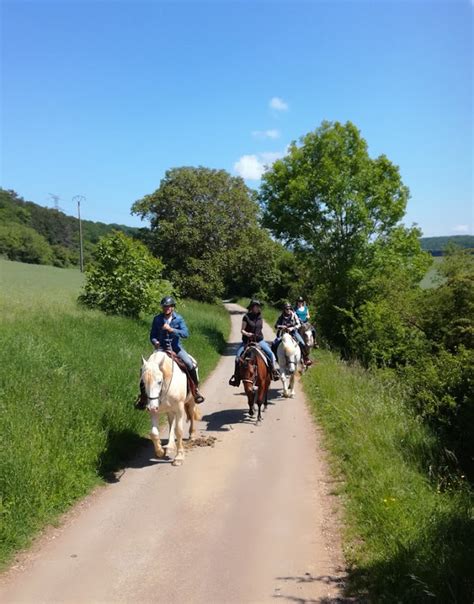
[239,344,272,422]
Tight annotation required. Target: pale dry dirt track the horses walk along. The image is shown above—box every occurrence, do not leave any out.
[0,304,343,604]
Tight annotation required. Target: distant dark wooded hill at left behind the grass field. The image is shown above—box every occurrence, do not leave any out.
[0,188,140,267]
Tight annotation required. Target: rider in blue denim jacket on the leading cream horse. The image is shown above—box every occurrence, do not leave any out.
[150,296,204,404]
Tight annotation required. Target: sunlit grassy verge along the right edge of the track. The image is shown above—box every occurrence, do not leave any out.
[303,352,474,603]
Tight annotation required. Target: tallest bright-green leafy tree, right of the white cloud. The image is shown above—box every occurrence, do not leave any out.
[260,122,426,353]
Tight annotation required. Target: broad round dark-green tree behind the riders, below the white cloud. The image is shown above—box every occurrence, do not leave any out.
[132,167,274,301]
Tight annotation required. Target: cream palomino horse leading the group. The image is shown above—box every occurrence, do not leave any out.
[141,350,199,466]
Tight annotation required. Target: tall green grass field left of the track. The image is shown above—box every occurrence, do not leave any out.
[0,260,230,564]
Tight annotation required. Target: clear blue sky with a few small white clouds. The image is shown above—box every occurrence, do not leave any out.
[0,0,474,236]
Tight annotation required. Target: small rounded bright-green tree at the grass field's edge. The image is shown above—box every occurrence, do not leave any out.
[79,232,173,318]
